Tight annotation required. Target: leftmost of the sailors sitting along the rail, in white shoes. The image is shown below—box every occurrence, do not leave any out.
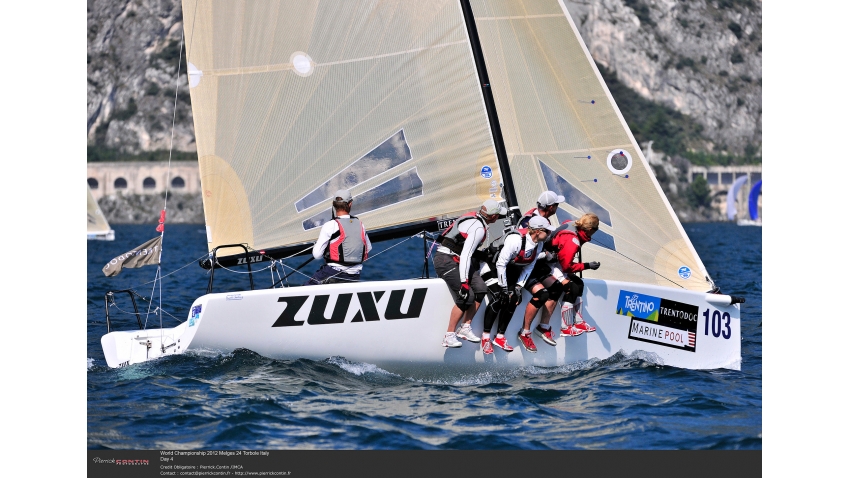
[433,199,508,347]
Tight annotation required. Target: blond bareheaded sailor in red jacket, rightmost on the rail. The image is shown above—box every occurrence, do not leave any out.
[520,213,599,351]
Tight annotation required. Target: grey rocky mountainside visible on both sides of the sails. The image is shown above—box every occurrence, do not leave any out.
[87,0,762,154]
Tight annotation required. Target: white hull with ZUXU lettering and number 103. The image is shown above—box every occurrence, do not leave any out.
[131,279,741,371]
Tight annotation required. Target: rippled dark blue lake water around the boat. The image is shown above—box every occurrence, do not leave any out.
[86,223,762,450]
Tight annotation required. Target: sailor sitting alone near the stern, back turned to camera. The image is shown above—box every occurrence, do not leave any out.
[304,189,372,285]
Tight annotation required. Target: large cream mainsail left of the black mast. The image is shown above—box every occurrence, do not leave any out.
[183,0,502,264]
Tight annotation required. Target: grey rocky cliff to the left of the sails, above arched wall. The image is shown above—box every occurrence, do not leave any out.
[87,0,195,153]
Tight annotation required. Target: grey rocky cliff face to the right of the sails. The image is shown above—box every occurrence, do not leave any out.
[566,0,762,155]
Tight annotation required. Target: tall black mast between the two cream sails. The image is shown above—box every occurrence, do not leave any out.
[460,0,522,224]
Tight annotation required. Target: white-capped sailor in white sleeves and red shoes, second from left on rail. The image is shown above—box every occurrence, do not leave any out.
[481,216,555,355]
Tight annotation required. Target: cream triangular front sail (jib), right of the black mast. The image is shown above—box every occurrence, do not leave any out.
[464,0,712,291]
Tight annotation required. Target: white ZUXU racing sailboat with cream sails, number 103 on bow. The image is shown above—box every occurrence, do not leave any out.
[101,0,741,371]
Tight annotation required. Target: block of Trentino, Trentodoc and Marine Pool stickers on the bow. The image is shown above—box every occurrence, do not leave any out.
[617,290,699,352]
